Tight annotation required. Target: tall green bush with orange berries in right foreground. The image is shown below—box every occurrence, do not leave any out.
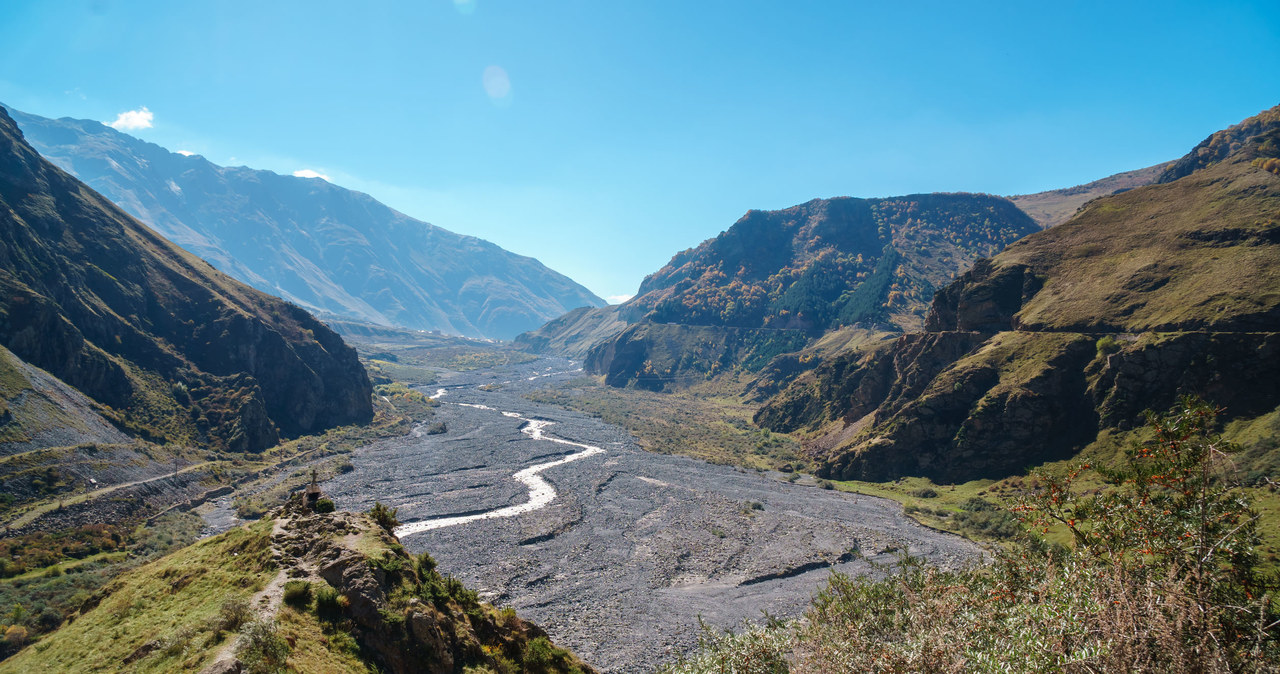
[1019,398,1267,629]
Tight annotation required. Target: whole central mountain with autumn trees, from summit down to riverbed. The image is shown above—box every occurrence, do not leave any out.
[517,193,1038,390]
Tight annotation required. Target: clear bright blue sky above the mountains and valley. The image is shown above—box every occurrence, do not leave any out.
[0,0,1280,297]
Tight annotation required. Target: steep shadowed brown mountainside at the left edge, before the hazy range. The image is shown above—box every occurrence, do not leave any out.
[0,105,372,450]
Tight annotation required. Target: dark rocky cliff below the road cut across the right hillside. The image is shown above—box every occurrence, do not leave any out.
[755,319,1280,482]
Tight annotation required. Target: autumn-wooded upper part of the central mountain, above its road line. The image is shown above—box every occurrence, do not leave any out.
[627,194,1038,331]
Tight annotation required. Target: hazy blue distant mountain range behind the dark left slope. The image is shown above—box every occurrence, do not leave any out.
[10,111,605,339]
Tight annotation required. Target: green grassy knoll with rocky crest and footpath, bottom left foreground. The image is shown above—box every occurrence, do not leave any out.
[0,499,591,674]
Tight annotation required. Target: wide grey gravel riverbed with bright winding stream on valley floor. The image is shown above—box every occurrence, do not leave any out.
[324,358,980,671]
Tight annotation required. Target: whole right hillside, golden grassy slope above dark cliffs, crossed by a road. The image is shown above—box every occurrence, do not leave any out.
[756,109,1280,482]
